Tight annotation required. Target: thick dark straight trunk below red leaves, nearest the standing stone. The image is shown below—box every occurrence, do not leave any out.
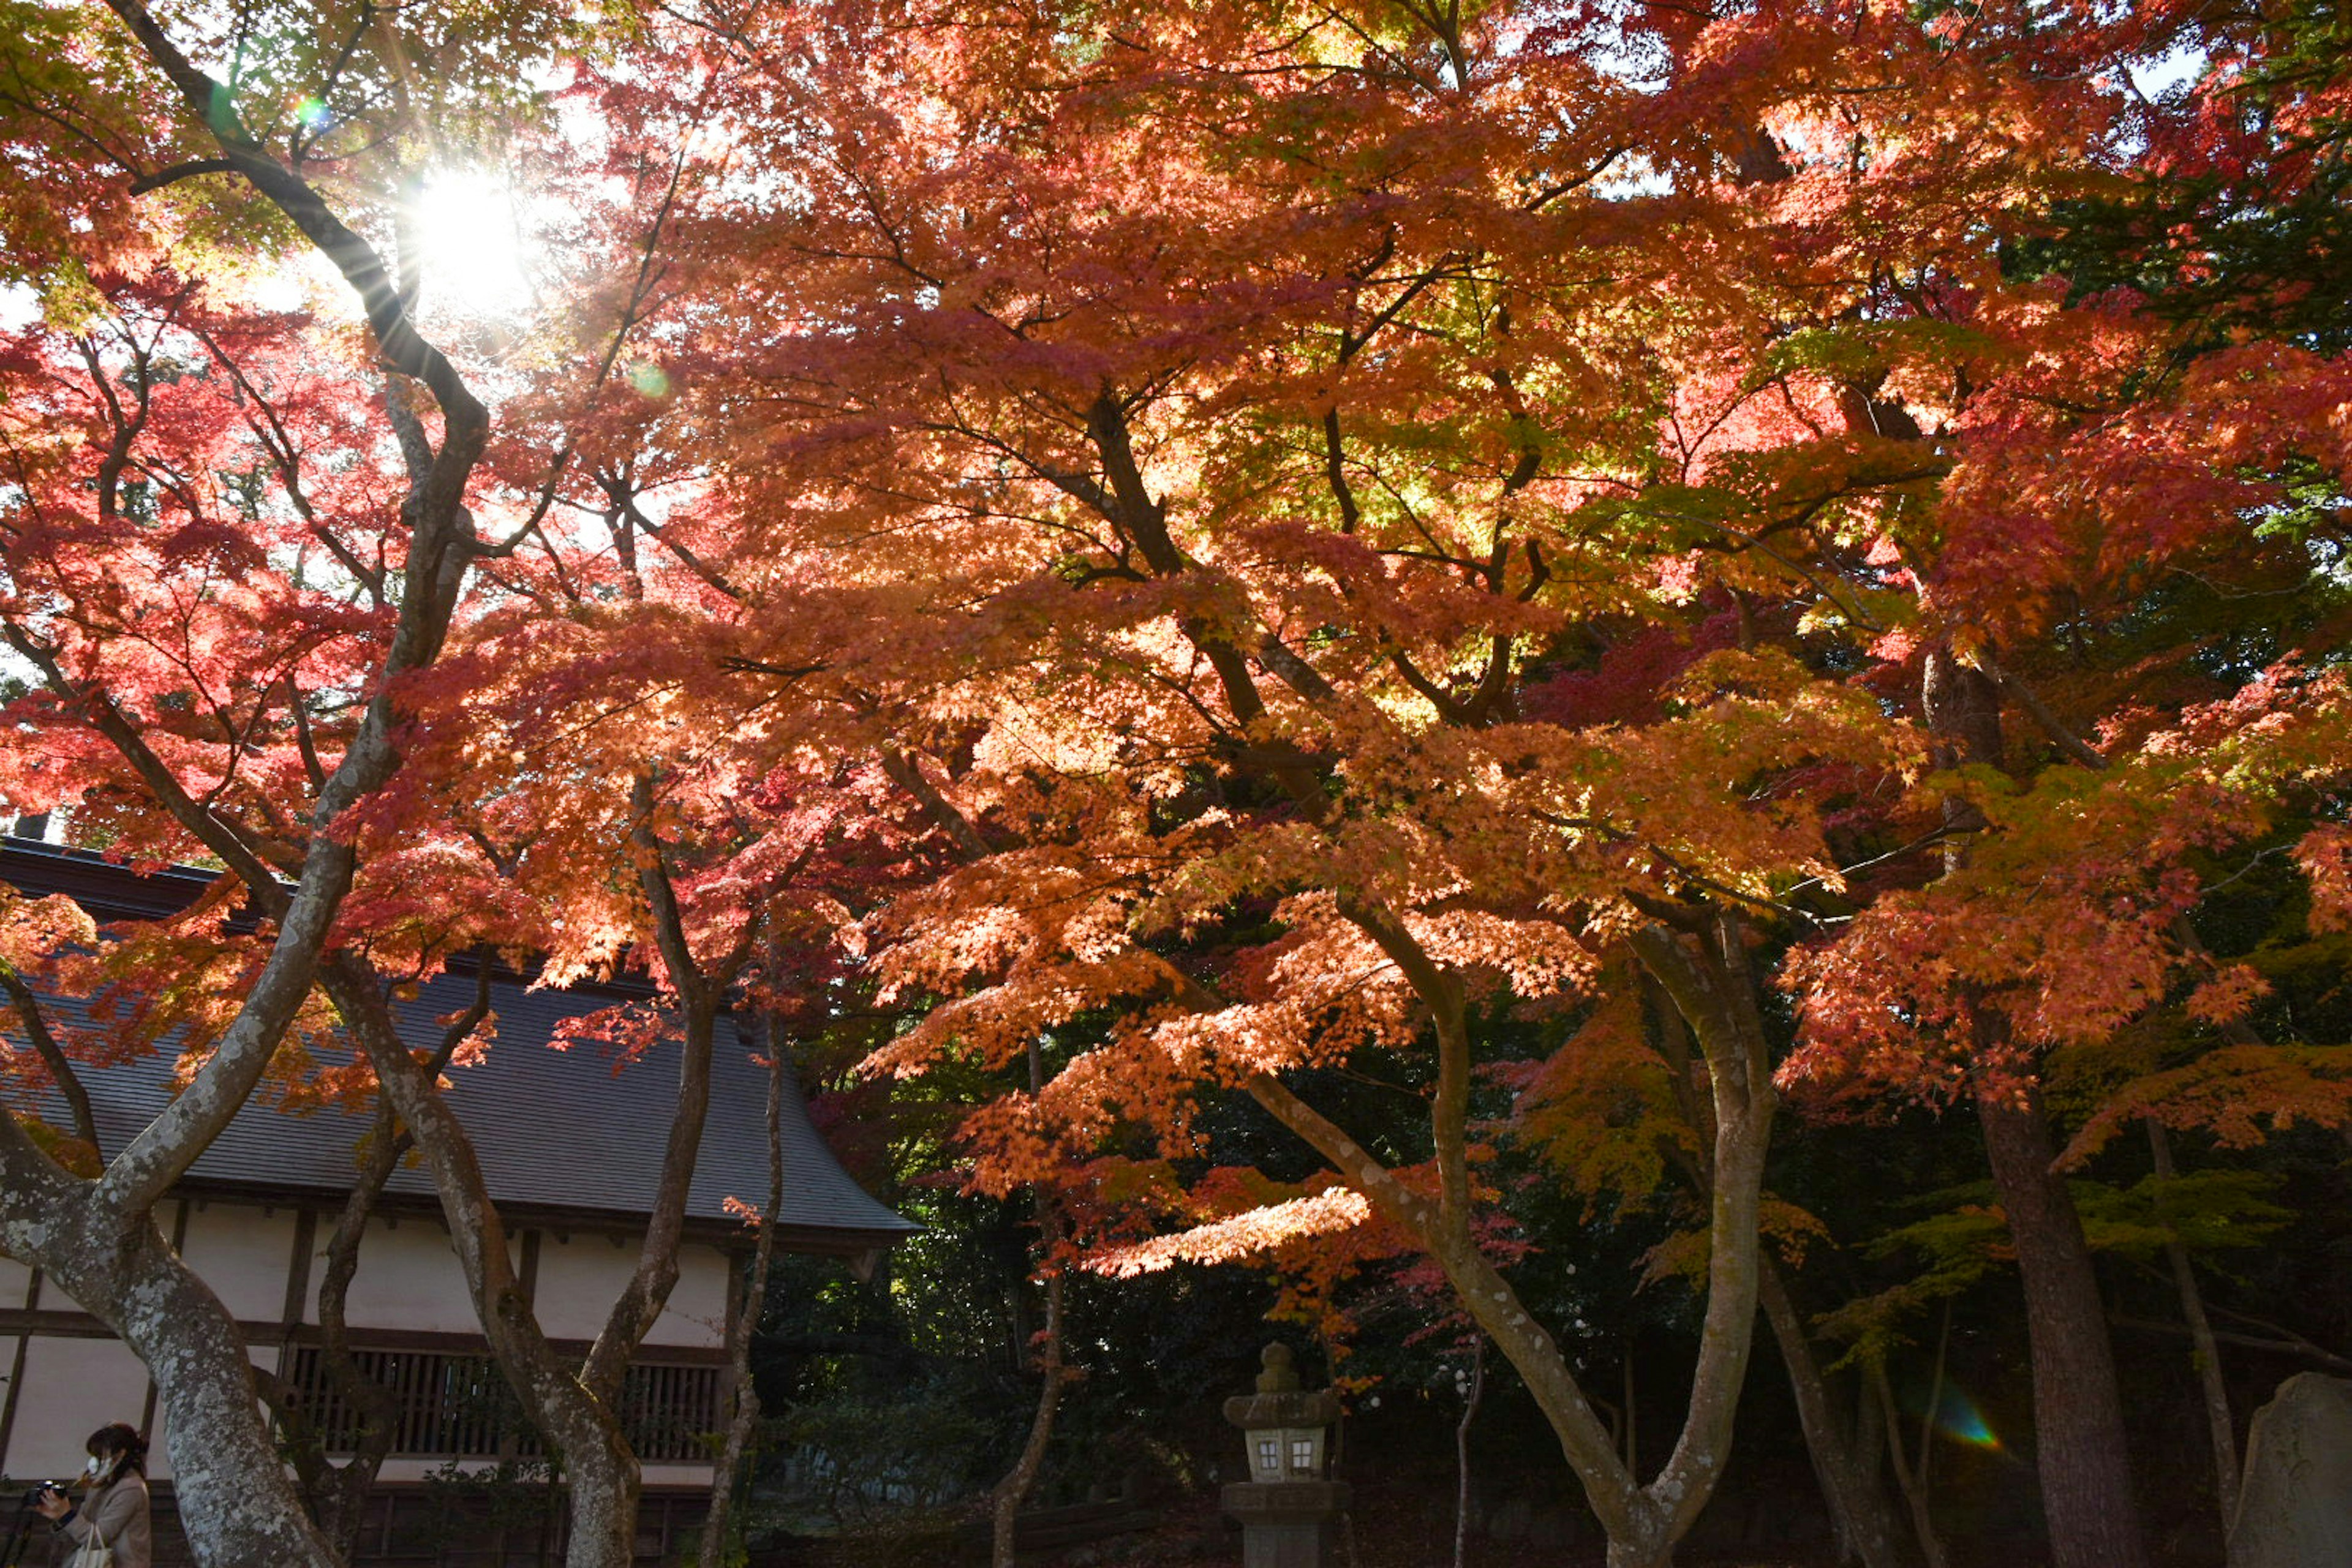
[1976,1091,2147,1568]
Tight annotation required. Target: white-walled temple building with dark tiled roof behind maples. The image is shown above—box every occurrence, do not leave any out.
[0,835,918,1568]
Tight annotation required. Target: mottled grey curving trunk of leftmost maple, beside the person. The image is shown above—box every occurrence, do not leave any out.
[0,0,489,1568]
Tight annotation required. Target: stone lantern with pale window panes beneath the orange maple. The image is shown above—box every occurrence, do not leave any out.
[1221,1344,1348,1568]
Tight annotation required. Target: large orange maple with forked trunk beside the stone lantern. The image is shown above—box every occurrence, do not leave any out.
[616,7,1975,1561]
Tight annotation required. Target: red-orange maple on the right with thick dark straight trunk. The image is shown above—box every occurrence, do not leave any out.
[1749,17,2347,1563]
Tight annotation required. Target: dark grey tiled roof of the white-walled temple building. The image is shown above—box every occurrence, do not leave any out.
[0,839,919,1253]
